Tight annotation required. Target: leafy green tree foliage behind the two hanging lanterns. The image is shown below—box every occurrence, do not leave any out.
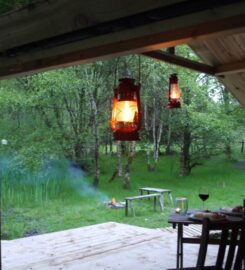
[0,46,245,171]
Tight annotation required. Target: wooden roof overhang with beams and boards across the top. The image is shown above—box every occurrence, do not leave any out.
[0,0,245,106]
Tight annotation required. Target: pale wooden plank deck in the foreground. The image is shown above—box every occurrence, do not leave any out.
[1,222,216,270]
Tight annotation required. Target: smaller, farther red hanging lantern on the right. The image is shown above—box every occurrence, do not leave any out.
[167,74,181,109]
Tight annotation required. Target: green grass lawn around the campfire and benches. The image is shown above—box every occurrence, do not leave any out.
[1,153,245,239]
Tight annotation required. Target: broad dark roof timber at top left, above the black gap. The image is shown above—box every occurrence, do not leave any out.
[0,0,184,51]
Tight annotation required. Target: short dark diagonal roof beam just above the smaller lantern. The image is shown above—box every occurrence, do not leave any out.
[143,51,215,75]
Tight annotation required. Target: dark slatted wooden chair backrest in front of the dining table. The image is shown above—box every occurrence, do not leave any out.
[196,219,245,270]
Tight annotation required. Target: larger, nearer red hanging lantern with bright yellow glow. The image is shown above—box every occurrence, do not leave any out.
[110,78,141,141]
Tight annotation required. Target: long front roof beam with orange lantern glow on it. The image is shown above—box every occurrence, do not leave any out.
[0,14,245,78]
